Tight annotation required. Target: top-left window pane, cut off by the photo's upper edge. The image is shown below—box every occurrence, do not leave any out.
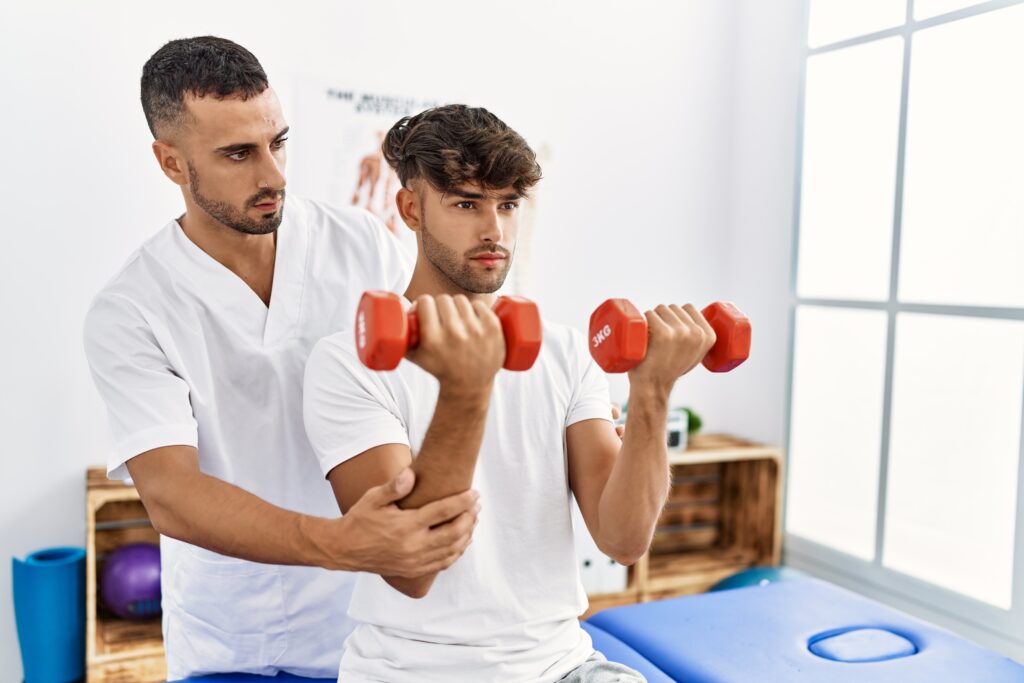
[807,0,906,47]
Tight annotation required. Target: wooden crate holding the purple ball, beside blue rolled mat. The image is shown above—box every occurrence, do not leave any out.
[85,468,167,683]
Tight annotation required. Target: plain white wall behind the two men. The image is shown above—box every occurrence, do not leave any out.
[0,0,800,680]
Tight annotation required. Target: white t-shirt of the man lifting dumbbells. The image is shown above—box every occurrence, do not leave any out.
[304,317,611,683]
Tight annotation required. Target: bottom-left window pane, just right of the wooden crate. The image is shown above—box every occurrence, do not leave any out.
[786,306,886,560]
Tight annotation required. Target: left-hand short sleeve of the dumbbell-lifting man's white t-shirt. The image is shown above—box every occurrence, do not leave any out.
[302,332,409,476]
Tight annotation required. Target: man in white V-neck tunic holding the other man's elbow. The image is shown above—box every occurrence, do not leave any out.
[85,37,476,680]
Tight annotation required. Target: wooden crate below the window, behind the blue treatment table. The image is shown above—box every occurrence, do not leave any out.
[587,434,782,615]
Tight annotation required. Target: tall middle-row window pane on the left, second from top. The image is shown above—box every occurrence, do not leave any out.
[797,38,903,300]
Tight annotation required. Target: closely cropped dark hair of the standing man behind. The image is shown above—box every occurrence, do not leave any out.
[142,36,269,137]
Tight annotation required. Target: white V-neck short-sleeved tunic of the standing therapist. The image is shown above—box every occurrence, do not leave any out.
[85,197,410,680]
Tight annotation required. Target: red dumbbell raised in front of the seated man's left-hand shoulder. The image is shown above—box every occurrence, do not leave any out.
[355,292,542,370]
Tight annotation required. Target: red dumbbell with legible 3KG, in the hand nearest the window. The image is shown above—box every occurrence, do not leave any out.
[590,299,751,373]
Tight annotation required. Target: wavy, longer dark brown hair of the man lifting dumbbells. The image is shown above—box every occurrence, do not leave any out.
[381,104,541,197]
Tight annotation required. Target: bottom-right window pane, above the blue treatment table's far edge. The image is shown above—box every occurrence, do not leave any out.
[883,313,1024,608]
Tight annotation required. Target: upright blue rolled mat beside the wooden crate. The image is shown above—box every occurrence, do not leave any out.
[11,548,85,683]
